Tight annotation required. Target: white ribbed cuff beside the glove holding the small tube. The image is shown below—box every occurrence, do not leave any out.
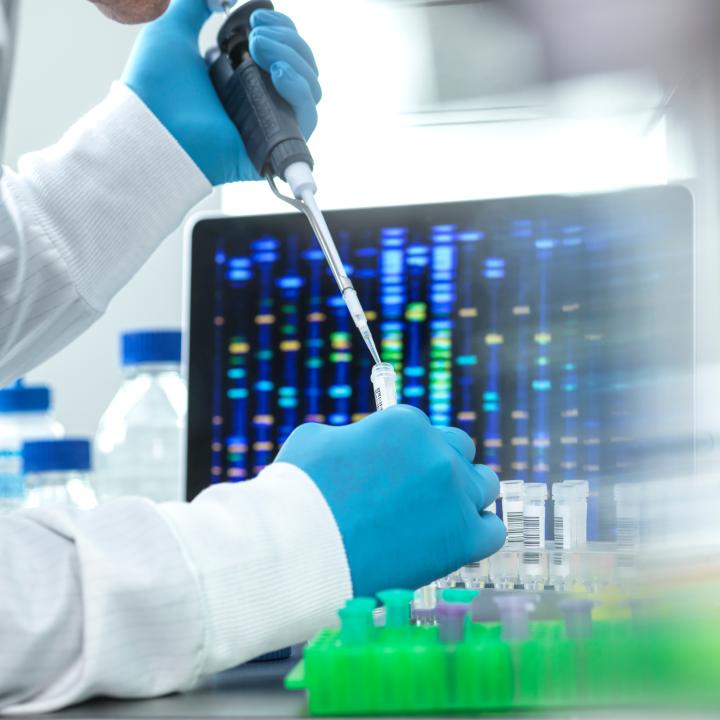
[161,463,352,673]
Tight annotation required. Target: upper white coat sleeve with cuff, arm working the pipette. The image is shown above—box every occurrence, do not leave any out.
[0,83,211,386]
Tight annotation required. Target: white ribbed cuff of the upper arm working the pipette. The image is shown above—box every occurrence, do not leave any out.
[18,83,212,312]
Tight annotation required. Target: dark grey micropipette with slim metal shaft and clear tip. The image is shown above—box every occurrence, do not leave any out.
[206,0,380,363]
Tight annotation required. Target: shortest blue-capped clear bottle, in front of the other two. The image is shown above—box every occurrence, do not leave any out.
[22,438,97,510]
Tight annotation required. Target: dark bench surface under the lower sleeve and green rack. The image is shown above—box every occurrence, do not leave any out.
[46,659,717,720]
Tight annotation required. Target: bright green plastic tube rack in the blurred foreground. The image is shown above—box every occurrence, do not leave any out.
[285,591,718,715]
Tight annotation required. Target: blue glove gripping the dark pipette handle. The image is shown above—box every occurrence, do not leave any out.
[123,0,321,185]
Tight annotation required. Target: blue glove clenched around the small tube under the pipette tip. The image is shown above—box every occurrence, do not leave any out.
[277,405,505,595]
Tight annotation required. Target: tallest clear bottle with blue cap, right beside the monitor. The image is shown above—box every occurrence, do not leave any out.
[95,330,187,502]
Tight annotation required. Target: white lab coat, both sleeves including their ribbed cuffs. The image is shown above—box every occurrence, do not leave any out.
[0,84,351,713]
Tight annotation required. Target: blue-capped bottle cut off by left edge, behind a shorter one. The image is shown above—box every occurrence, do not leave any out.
[0,380,63,514]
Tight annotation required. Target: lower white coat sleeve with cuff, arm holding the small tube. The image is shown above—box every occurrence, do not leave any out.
[0,463,351,714]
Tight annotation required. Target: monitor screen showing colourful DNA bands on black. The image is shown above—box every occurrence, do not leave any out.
[188,188,693,537]
